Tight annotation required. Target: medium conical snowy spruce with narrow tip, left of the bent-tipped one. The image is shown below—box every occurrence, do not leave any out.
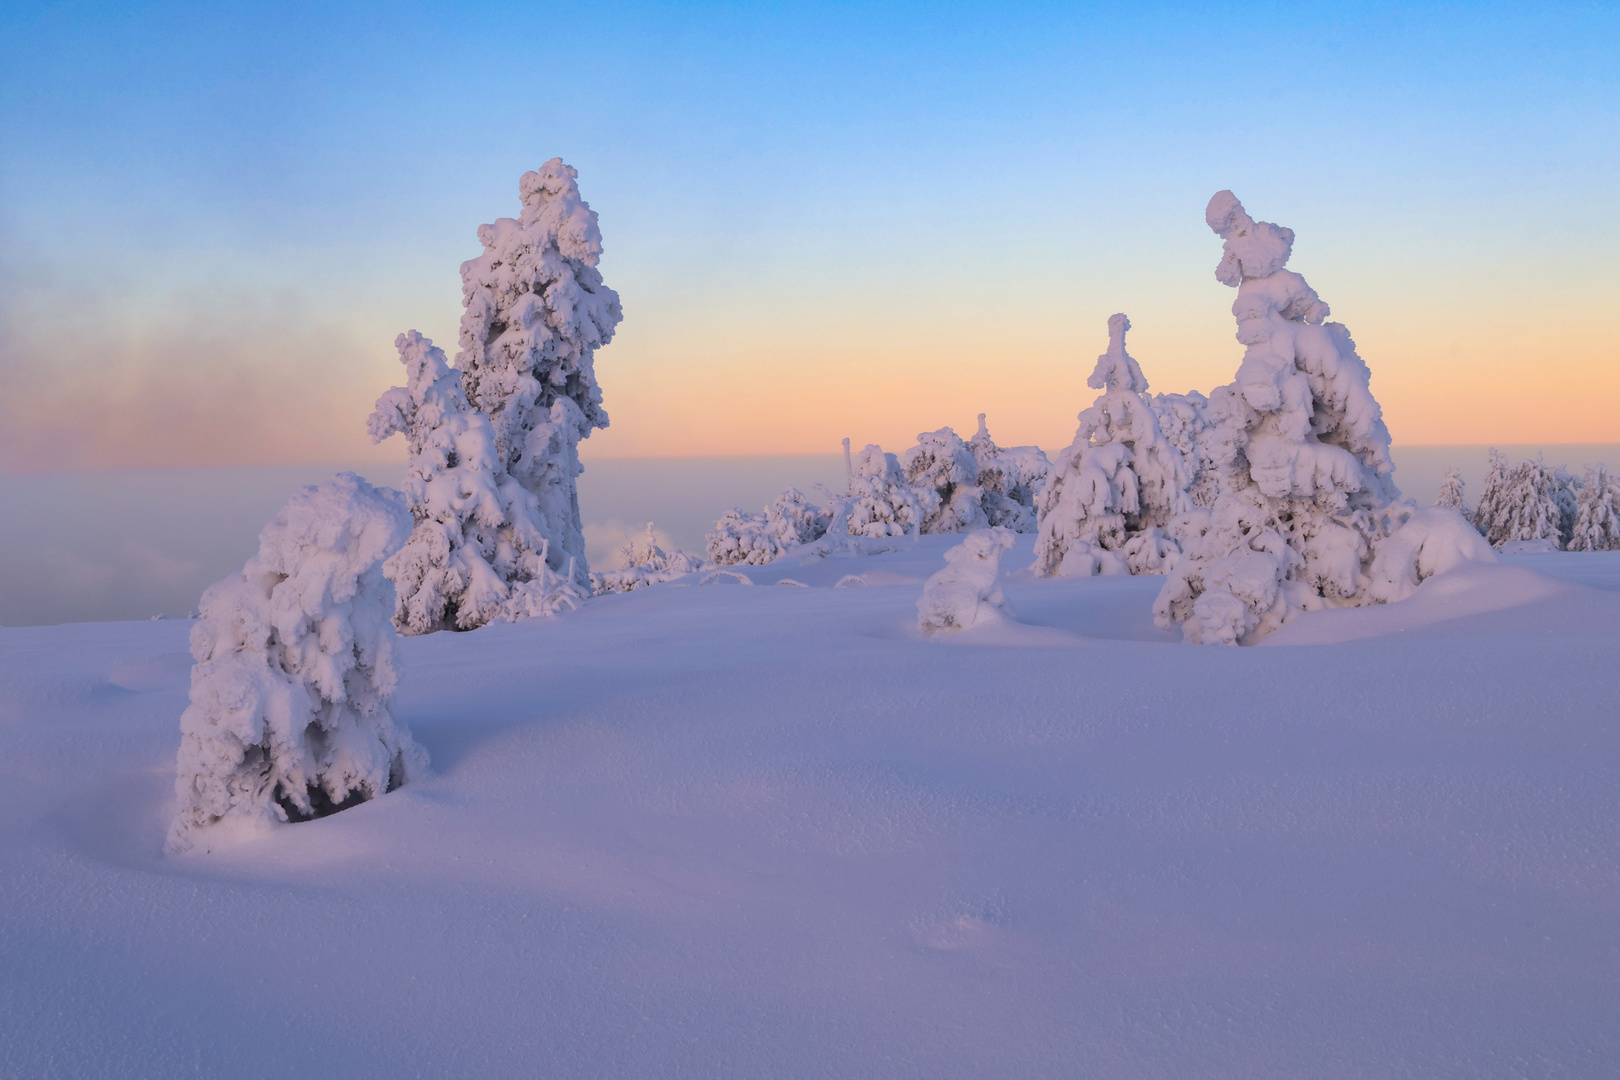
[1035,314,1192,576]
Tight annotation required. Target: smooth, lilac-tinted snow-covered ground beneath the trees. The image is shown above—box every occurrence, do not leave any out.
[0,536,1620,1078]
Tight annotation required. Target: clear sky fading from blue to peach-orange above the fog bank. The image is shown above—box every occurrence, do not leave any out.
[0,2,1620,471]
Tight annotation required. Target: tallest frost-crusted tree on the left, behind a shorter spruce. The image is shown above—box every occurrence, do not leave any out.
[455,157,624,586]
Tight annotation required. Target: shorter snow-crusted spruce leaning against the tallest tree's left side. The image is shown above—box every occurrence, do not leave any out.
[368,330,585,633]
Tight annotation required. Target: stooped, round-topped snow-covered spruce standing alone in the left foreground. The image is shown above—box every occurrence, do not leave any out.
[168,473,428,852]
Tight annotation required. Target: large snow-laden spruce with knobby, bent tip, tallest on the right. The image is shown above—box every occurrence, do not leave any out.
[1153,191,1409,644]
